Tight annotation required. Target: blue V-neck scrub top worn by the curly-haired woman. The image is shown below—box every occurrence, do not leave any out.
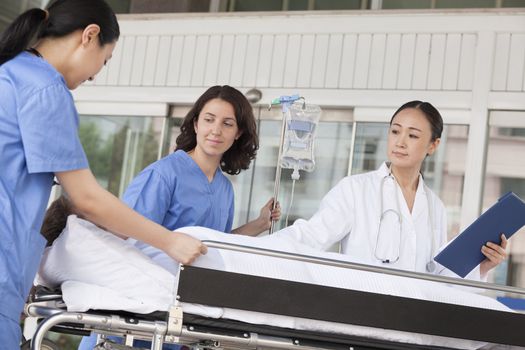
[123,150,234,239]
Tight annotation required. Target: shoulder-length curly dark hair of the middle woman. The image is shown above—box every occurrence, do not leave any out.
[175,85,259,175]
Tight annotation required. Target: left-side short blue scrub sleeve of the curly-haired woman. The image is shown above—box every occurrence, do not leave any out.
[122,169,173,225]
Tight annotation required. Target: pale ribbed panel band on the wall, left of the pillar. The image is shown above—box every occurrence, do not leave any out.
[96,33,478,91]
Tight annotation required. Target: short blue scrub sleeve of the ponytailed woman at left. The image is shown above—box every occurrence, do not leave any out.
[18,83,88,173]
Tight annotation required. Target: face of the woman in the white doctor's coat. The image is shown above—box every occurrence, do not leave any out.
[388,108,439,168]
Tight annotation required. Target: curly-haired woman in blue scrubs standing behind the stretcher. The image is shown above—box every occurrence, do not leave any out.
[79,85,280,350]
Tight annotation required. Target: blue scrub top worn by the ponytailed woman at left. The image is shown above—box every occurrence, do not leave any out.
[0,52,88,334]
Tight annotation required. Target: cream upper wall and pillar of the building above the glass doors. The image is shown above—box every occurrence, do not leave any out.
[75,10,525,230]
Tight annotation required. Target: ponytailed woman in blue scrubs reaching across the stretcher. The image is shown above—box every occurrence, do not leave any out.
[0,0,206,350]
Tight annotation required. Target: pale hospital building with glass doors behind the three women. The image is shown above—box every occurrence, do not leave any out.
[4,0,525,287]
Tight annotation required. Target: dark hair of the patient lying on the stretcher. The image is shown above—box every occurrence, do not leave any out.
[40,195,74,247]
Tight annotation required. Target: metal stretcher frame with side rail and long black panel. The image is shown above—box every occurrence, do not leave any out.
[26,241,525,350]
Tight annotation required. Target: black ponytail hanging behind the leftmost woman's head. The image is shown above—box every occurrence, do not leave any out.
[0,8,47,65]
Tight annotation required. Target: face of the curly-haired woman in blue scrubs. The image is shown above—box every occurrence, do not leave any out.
[194,98,241,159]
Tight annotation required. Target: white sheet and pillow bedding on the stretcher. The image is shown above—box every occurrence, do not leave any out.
[37,216,511,349]
